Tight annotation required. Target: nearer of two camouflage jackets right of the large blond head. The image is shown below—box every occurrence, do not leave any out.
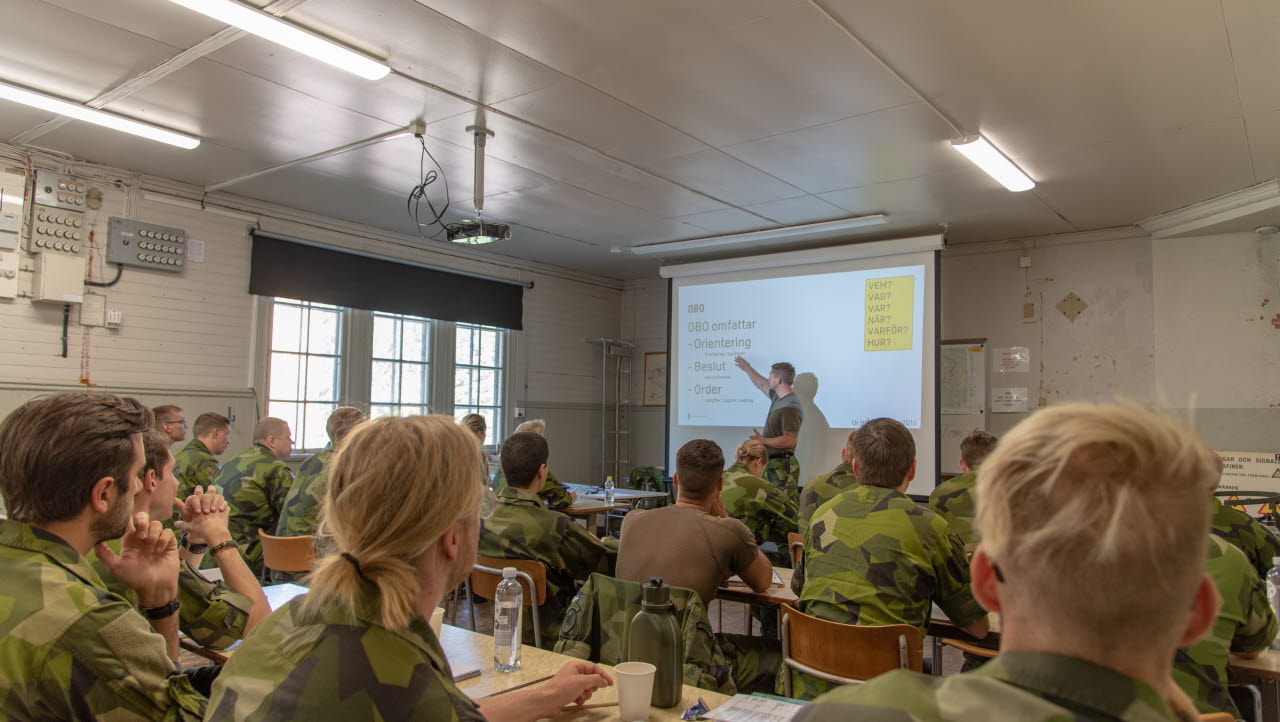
[1174,535,1276,719]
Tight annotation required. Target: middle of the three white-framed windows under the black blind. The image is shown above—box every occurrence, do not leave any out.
[369,314,431,416]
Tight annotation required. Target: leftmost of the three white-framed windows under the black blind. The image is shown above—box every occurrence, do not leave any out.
[266,298,343,449]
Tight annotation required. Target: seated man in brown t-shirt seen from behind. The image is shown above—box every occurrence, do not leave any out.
[617,439,782,691]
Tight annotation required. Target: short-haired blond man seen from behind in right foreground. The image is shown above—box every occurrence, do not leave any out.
[797,403,1219,722]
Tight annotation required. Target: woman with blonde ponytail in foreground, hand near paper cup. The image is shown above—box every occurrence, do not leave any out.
[209,416,612,722]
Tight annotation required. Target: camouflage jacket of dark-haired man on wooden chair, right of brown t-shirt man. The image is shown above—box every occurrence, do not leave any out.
[778,484,987,699]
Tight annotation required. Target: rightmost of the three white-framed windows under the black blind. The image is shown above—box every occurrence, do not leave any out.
[453,324,507,445]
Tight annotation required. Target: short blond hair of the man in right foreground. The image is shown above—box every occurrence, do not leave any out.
[977,403,1216,645]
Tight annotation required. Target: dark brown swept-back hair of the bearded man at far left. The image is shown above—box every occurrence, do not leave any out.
[0,392,152,525]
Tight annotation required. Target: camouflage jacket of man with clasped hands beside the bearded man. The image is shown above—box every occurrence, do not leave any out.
[87,539,253,649]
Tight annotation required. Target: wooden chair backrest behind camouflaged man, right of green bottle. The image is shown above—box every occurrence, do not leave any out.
[781,604,924,696]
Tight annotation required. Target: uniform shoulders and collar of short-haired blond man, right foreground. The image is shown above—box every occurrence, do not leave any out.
[795,652,1181,722]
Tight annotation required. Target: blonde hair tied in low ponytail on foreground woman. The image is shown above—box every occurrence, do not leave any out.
[303,416,484,630]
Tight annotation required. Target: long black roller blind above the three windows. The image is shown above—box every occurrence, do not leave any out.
[248,232,525,330]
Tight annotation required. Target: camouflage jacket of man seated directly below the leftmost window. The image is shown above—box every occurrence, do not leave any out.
[215,444,293,577]
